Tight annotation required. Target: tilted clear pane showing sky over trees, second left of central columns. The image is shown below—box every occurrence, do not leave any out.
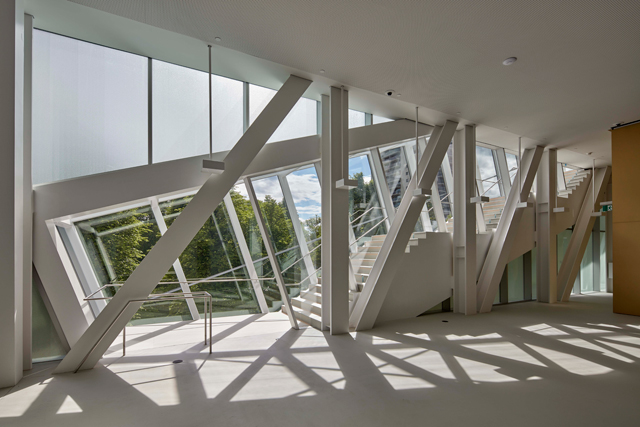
[252,176,311,296]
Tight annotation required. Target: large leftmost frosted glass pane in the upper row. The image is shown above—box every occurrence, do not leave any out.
[33,30,148,184]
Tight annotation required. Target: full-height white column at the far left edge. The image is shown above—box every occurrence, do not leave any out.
[0,0,25,387]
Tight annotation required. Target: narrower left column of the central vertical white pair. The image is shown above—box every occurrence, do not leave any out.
[319,95,335,331]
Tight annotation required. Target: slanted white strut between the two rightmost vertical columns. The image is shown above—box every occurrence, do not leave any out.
[477,146,544,313]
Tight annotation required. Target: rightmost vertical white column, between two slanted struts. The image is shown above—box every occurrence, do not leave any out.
[536,148,558,304]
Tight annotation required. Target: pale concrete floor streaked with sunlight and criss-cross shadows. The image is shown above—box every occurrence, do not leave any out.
[0,294,640,427]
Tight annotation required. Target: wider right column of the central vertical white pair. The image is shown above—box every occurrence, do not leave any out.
[322,87,351,335]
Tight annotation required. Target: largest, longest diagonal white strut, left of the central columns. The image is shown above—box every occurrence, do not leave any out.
[55,76,311,373]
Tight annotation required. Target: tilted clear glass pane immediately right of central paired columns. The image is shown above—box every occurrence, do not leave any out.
[349,154,387,246]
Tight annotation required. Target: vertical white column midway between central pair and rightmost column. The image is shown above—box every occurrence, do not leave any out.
[453,125,477,315]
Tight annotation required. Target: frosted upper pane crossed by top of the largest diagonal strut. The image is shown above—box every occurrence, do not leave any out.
[249,85,318,142]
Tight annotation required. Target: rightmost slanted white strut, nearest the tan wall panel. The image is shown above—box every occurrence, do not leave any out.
[558,166,611,302]
